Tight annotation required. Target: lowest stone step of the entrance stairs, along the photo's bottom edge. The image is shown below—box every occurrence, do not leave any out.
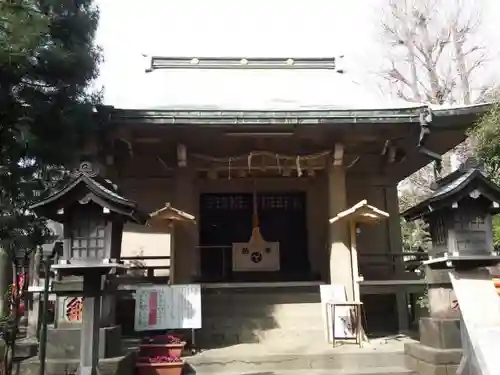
[187,351,411,374]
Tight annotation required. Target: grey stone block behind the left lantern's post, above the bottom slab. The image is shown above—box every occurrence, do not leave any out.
[47,324,122,359]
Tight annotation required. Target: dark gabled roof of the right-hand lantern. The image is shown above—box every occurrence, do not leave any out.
[401,168,500,220]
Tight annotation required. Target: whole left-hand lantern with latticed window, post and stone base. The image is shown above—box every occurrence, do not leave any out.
[28,162,147,375]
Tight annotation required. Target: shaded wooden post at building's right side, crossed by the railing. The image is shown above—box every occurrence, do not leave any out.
[384,184,410,332]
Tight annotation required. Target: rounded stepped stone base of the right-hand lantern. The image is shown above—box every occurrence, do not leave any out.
[405,318,462,375]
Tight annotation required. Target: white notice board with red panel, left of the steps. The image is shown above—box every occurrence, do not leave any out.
[134,284,201,331]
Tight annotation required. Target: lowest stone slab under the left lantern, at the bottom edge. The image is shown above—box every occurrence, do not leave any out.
[19,352,135,375]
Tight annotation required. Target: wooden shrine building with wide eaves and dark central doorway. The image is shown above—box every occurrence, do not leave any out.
[94,58,489,340]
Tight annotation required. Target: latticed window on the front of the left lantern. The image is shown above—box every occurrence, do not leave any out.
[71,218,105,259]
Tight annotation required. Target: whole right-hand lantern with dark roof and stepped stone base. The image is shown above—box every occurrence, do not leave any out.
[402,164,500,374]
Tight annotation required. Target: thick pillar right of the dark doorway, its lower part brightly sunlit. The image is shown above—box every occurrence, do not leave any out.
[327,166,354,300]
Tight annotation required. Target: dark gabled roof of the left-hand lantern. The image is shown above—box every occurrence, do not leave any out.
[30,168,149,224]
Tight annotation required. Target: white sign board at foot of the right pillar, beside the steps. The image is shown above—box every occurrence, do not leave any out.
[319,284,355,342]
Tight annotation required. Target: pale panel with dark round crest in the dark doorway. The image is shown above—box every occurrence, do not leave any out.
[233,242,280,272]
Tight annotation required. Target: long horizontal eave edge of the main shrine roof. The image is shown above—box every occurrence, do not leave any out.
[111,103,491,128]
